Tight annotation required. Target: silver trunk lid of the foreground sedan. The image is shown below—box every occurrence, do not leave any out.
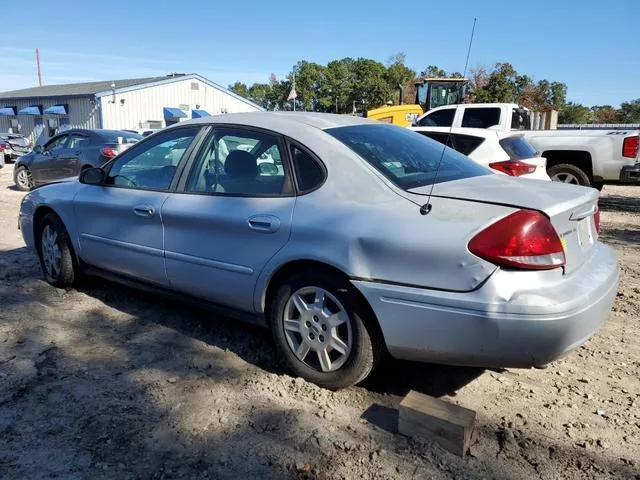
[410,175,599,273]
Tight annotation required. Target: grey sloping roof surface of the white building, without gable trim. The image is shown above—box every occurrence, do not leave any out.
[0,75,184,99]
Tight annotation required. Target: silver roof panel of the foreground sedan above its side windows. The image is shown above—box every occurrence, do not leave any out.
[178,112,379,133]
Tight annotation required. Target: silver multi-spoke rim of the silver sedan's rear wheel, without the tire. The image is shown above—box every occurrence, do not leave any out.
[282,287,353,372]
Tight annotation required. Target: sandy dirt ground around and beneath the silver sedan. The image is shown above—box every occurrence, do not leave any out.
[0,165,640,480]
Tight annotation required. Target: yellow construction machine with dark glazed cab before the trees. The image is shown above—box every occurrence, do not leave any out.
[365,78,469,127]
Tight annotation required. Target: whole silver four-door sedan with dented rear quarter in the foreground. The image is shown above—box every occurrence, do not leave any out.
[19,112,618,389]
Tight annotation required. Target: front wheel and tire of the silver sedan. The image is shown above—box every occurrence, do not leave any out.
[36,213,80,288]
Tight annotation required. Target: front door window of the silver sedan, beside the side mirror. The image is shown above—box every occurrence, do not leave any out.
[105,127,200,190]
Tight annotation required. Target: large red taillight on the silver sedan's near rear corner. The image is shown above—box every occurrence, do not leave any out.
[469,210,566,270]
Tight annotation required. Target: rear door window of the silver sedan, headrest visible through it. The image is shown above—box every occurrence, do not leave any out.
[187,128,291,196]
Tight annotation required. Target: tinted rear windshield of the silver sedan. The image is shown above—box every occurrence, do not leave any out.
[325,124,490,190]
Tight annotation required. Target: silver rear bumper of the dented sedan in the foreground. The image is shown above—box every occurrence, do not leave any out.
[353,244,618,367]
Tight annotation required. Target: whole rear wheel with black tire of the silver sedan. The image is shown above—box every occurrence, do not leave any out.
[269,272,380,390]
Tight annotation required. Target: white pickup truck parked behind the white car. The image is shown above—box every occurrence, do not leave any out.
[414,103,640,188]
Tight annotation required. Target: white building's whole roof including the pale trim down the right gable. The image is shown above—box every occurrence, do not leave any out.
[0,73,264,110]
